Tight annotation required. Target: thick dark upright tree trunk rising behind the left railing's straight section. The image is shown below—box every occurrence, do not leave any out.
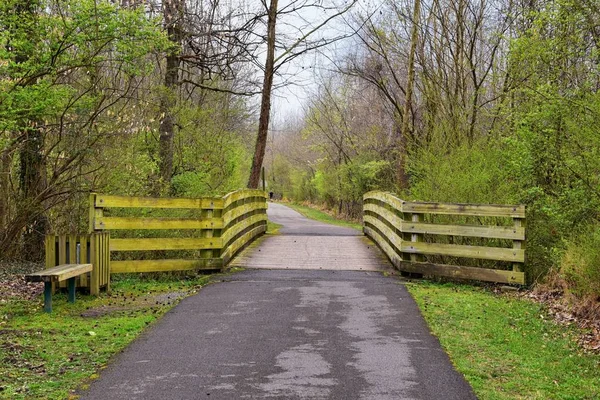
[158,0,184,186]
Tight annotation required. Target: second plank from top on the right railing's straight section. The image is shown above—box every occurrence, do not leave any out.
[401,220,525,240]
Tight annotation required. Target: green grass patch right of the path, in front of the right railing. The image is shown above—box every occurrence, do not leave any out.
[407,282,600,400]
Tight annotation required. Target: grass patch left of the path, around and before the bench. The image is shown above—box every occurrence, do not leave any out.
[0,274,216,399]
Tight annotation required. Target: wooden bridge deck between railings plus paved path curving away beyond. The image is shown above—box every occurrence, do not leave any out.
[231,203,392,271]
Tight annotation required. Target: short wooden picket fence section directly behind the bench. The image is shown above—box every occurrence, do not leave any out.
[46,232,110,295]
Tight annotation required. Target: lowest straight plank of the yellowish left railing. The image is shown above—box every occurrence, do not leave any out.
[111,258,223,274]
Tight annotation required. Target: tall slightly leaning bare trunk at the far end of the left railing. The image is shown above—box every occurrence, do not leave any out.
[248,0,277,189]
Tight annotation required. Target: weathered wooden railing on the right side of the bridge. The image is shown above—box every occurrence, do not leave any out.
[363,191,525,284]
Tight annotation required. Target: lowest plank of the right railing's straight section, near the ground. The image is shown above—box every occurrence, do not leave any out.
[396,261,525,285]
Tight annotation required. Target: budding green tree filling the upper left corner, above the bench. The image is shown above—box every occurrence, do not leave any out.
[0,0,165,259]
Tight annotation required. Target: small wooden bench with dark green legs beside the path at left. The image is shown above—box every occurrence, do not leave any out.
[25,264,92,313]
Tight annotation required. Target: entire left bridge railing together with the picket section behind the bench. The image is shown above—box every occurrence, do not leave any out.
[46,190,267,294]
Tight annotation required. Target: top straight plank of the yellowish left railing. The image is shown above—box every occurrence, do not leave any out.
[95,194,223,209]
